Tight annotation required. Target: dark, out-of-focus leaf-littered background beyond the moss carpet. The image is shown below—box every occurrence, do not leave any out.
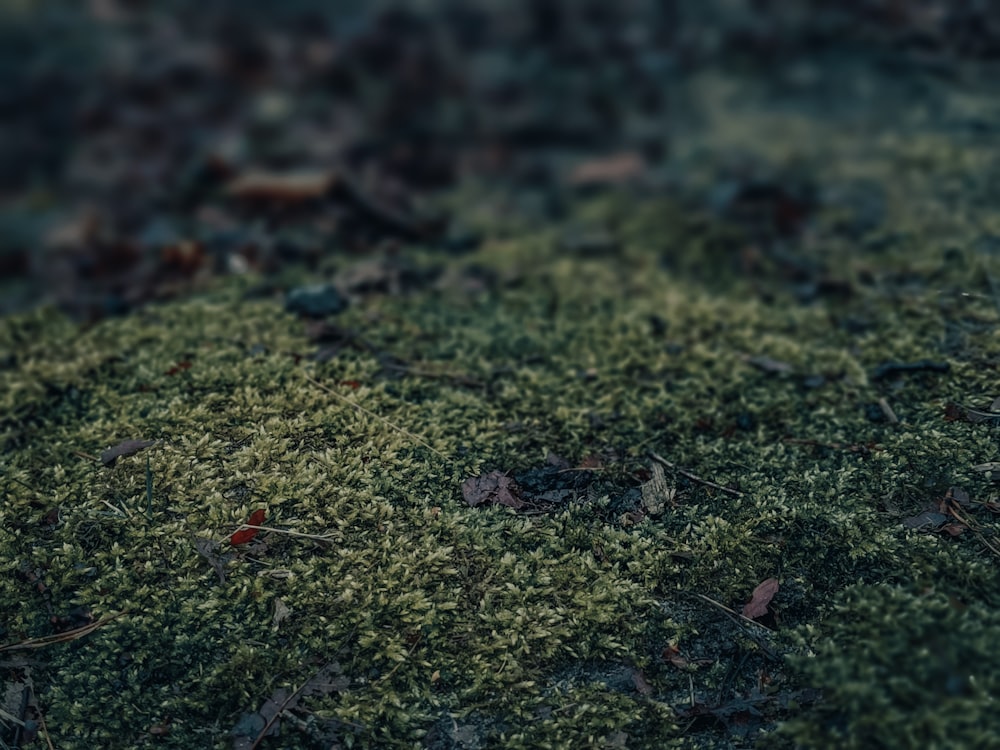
[0,0,1000,320]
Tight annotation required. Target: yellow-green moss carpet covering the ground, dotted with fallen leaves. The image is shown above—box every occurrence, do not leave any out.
[0,63,1000,749]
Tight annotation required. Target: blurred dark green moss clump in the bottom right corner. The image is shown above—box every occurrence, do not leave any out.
[765,585,1000,748]
